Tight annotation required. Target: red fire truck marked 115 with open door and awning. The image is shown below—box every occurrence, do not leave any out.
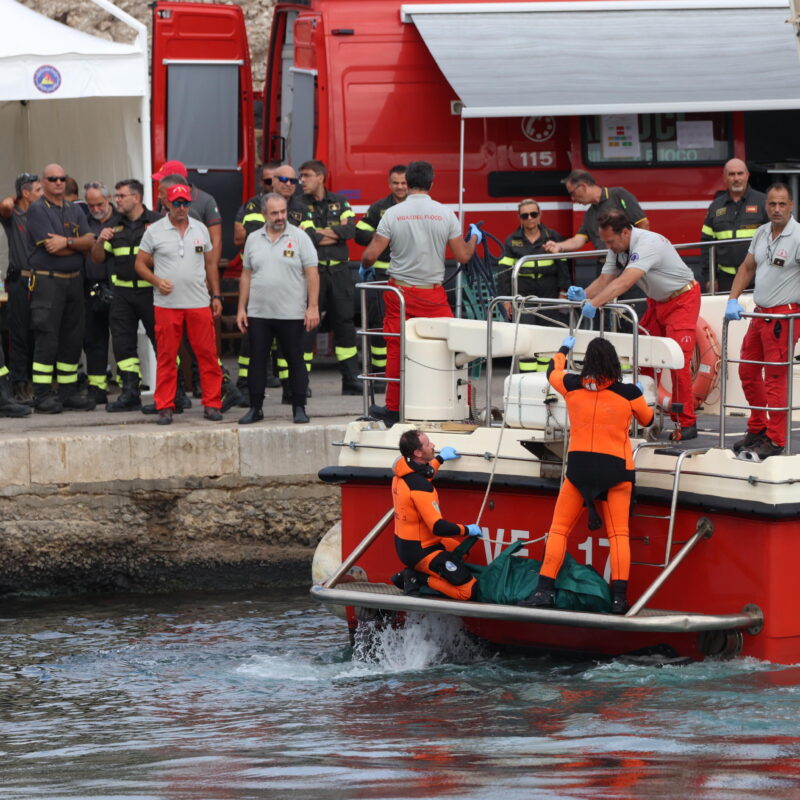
[153,0,800,256]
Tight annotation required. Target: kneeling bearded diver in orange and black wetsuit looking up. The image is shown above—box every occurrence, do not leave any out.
[392,430,482,600]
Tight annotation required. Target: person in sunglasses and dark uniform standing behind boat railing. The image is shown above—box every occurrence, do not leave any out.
[497,198,572,372]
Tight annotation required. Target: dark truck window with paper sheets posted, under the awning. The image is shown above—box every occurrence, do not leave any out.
[582,112,733,167]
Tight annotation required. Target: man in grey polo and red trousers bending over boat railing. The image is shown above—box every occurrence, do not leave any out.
[567,211,700,441]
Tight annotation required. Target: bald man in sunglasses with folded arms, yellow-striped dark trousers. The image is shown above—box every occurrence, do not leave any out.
[22,164,95,414]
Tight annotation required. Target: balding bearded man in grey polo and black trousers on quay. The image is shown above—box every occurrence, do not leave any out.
[236,192,319,425]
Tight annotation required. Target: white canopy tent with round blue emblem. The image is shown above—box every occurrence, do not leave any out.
[0,0,152,196]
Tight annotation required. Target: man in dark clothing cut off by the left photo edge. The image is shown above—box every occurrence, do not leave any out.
[0,172,42,405]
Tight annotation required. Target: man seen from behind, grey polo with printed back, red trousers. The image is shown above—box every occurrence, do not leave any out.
[359,161,483,425]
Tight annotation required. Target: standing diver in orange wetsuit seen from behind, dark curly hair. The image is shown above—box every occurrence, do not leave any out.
[520,336,653,614]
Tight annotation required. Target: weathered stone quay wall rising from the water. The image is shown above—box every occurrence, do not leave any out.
[0,375,361,593]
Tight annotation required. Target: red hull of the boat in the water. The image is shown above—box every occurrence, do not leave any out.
[328,475,800,663]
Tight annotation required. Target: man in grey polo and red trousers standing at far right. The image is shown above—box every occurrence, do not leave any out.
[725,183,800,460]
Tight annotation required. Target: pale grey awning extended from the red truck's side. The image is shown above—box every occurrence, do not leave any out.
[401,0,800,117]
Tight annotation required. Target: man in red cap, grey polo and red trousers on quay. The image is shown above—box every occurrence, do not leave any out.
[134,184,222,425]
